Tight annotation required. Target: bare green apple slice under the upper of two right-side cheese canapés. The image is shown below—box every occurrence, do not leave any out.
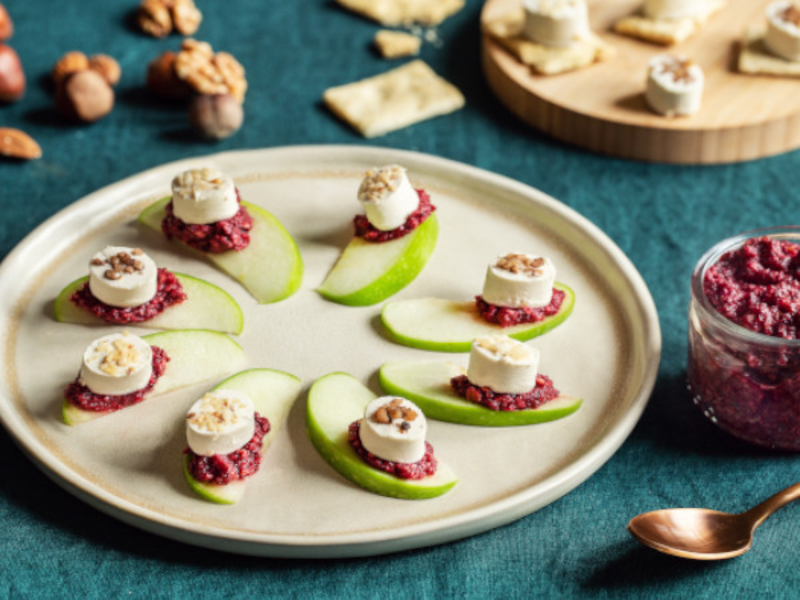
[381,283,575,352]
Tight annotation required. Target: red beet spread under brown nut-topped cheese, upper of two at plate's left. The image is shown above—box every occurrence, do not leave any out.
[70,269,186,325]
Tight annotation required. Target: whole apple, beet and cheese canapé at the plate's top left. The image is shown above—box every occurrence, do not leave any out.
[139,169,303,303]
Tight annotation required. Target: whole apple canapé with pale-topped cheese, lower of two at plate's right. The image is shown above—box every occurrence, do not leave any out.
[380,335,582,427]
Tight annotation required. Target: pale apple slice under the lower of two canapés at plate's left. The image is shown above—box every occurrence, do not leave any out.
[61,329,246,425]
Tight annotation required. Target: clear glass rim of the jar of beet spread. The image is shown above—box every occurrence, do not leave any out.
[691,225,800,349]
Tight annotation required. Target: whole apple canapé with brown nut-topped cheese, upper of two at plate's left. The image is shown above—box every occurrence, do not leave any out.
[54,246,244,333]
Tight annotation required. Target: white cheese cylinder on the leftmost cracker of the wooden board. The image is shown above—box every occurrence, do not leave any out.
[523,0,589,47]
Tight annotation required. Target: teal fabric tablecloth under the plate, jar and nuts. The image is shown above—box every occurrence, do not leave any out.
[0,0,800,598]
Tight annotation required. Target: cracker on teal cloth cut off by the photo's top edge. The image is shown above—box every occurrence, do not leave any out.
[336,0,464,27]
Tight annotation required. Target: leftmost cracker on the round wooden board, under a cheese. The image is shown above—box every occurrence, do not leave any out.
[486,9,616,75]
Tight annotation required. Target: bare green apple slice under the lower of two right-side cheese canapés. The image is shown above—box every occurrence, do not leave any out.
[380,361,583,427]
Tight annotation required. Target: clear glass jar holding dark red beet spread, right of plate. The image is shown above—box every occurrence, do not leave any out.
[688,226,800,450]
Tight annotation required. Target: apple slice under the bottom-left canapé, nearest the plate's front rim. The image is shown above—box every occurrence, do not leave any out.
[183,369,302,504]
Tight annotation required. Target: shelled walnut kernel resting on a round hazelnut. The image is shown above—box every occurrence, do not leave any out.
[174,39,247,104]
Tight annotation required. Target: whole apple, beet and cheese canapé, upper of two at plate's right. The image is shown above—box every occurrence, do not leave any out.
[381,252,575,352]
